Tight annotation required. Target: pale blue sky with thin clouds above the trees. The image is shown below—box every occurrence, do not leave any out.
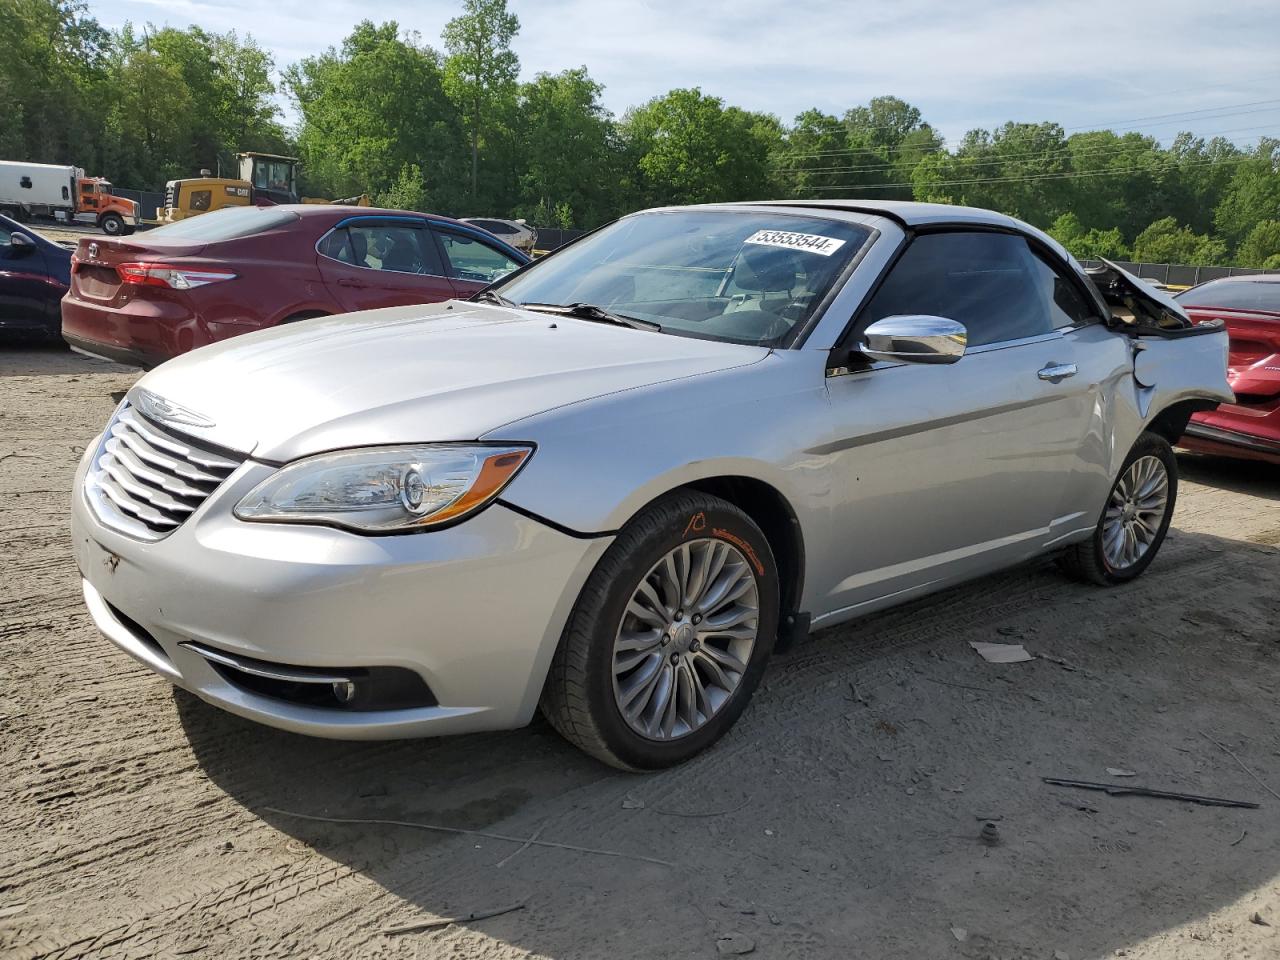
[90,0,1280,143]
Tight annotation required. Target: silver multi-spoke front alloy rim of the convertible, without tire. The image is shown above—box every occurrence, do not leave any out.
[613,538,760,740]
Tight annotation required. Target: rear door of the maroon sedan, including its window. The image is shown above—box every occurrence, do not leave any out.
[316,218,454,311]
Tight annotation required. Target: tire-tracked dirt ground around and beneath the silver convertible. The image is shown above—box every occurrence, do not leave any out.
[0,348,1280,960]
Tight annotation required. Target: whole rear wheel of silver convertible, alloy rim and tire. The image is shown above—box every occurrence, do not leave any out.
[1061,433,1178,586]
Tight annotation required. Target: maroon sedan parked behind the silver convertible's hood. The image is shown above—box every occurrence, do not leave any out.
[61,204,529,367]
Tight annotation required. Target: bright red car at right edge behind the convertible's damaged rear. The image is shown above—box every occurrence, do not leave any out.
[1176,274,1280,463]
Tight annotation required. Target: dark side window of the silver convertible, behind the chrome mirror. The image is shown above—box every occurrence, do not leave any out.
[858,232,1059,347]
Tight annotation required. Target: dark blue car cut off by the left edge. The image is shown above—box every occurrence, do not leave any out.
[0,216,72,340]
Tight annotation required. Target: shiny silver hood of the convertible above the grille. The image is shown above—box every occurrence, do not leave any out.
[131,301,768,461]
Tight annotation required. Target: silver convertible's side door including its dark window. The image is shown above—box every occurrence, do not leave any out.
[827,232,1098,611]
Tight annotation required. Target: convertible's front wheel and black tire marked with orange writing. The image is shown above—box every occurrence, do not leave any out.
[540,492,780,771]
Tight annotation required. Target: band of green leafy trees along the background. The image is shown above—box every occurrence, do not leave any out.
[0,0,1280,268]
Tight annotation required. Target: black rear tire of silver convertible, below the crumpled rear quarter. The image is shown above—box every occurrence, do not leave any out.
[1059,433,1178,586]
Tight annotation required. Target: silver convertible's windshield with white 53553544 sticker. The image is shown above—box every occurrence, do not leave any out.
[495,210,870,344]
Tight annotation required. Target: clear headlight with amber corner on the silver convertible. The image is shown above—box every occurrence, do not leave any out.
[236,443,534,534]
